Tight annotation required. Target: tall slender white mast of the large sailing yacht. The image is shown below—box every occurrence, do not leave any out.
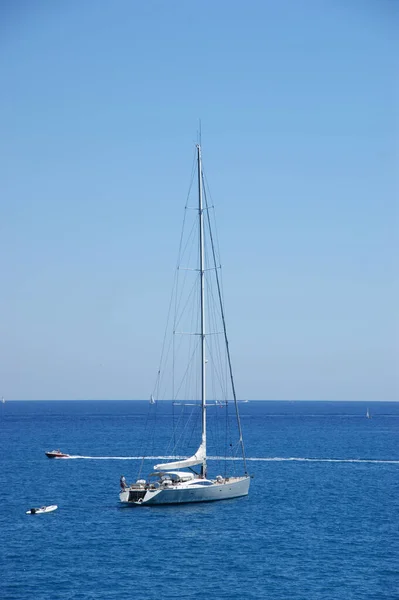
[197,144,206,475]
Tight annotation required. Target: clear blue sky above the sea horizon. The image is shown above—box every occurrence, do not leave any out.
[0,0,399,400]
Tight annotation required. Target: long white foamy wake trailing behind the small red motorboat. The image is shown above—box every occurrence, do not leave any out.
[63,454,399,465]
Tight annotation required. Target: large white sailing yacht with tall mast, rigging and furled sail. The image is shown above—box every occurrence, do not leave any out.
[119,144,250,505]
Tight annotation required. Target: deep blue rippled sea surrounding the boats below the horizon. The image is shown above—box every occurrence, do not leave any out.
[0,401,399,600]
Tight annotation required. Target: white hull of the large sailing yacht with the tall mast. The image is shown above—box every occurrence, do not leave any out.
[119,476,250,506]
